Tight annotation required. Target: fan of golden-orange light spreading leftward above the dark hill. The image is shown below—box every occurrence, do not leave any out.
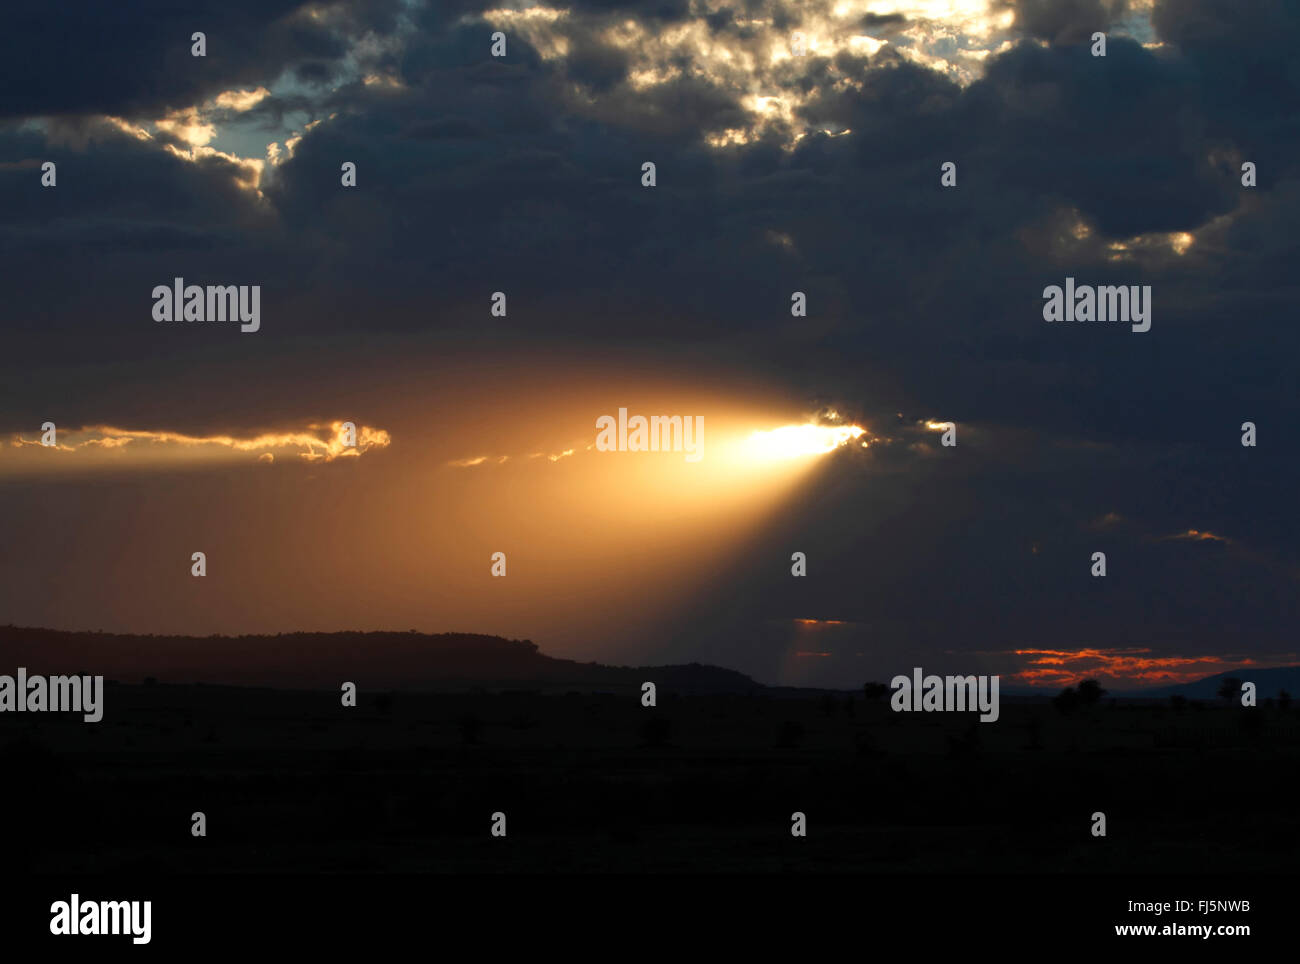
[0,351,867,661]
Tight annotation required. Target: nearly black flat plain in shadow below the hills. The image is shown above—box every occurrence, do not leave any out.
[0,683,1300,874]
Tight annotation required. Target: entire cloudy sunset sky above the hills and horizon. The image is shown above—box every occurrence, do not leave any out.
[0,0,1300,690]
